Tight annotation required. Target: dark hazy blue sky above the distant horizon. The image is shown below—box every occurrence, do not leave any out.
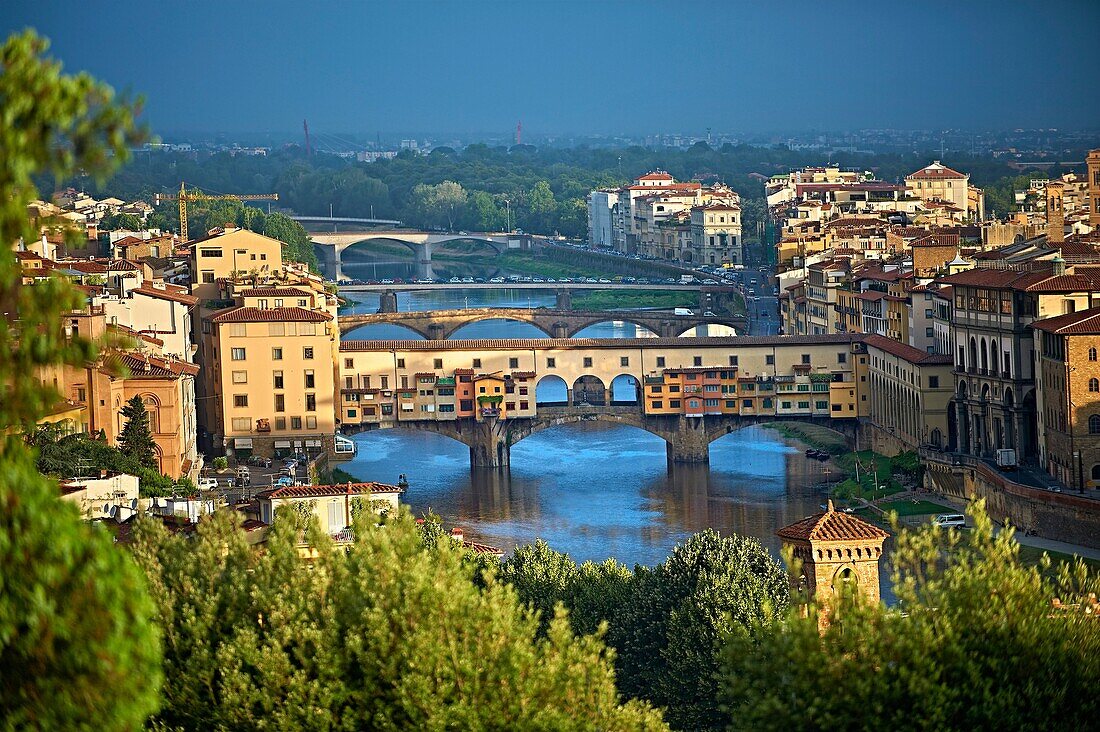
[0,0,1100,133]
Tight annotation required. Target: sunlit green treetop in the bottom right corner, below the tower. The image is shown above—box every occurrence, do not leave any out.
[722,502,1100,730]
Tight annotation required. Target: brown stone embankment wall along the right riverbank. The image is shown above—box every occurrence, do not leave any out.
[921,451,1100,548]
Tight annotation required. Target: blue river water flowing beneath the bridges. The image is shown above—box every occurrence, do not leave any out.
[341,275,849,566]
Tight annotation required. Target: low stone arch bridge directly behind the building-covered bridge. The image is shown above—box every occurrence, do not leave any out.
[340,307,746,340]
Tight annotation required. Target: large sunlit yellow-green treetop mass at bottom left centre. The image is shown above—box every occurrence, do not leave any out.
[126,512,663,730]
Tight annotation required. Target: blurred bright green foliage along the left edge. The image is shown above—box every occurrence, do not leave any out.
[0,27,162,730]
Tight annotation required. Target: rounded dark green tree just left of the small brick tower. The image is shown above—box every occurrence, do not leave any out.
[608,529,789,730]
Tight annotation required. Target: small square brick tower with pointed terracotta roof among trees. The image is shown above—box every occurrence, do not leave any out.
[777,501,890,607]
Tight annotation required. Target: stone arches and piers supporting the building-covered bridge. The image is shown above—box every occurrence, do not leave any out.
[343,405,860,468]
